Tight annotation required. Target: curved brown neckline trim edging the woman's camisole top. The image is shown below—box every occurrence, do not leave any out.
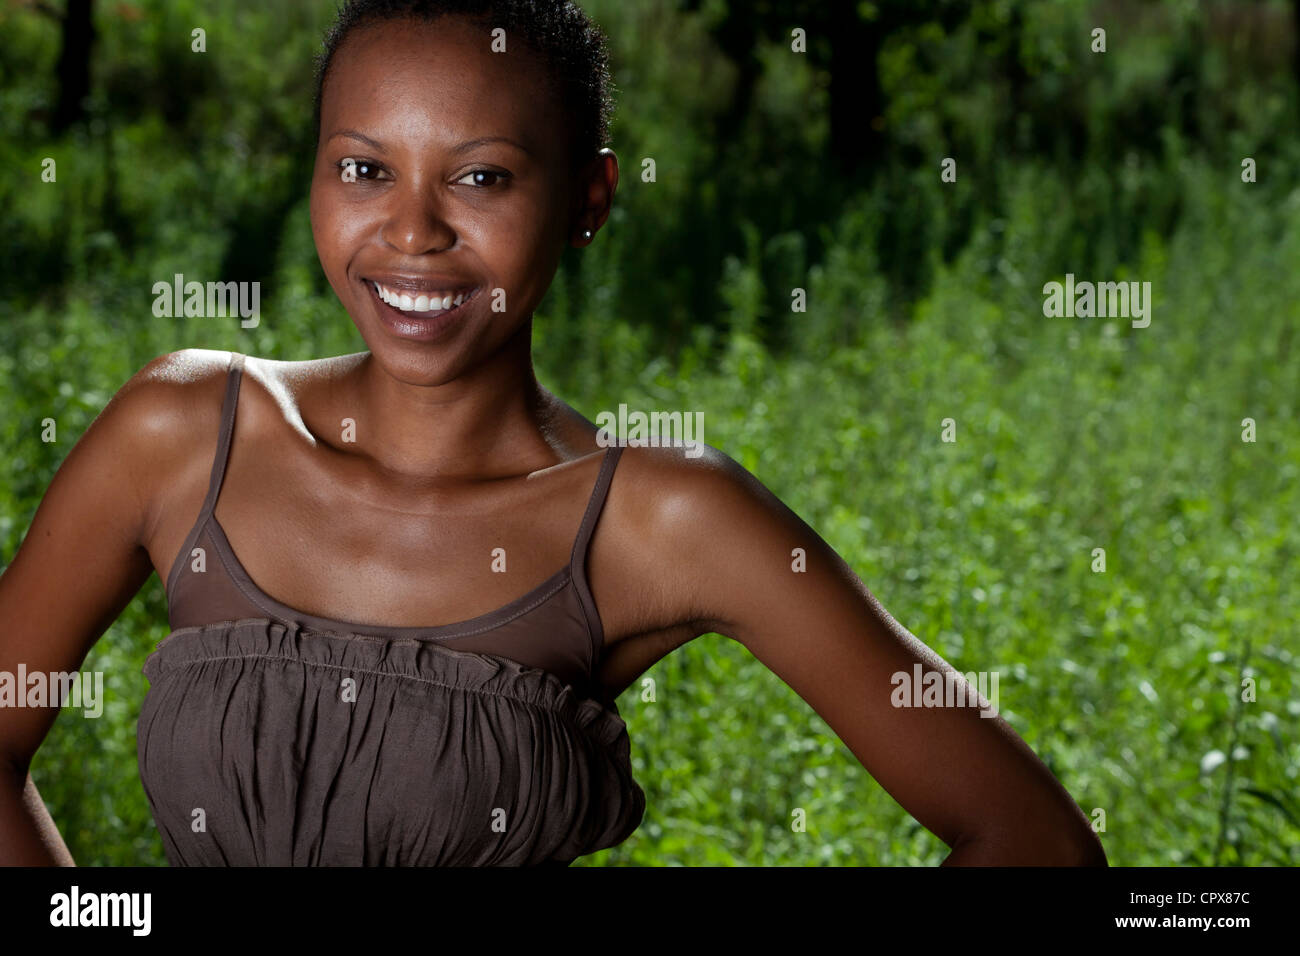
[205,510,573,640]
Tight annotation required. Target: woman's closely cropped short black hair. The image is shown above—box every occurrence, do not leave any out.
[313,0,614,168]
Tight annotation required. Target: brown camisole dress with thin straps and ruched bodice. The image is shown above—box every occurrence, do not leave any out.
[137,352,645,866]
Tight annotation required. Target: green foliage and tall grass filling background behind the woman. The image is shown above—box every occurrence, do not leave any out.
[0,0,1300,865]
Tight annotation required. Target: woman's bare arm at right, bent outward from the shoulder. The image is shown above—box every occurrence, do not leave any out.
[639,446,1106,866]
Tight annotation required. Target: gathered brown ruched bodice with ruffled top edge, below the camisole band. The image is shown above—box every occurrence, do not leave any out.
[138,619,645,866]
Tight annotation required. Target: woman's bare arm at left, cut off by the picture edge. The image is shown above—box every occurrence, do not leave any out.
[0,350,225,865]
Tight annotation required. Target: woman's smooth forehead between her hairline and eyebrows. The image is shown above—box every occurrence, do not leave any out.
[321,17,562,156]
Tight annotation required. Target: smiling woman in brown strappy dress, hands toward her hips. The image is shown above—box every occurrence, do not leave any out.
[0,0,1105,865]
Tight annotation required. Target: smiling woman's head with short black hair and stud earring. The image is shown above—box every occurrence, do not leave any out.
[311,3,618,385]
